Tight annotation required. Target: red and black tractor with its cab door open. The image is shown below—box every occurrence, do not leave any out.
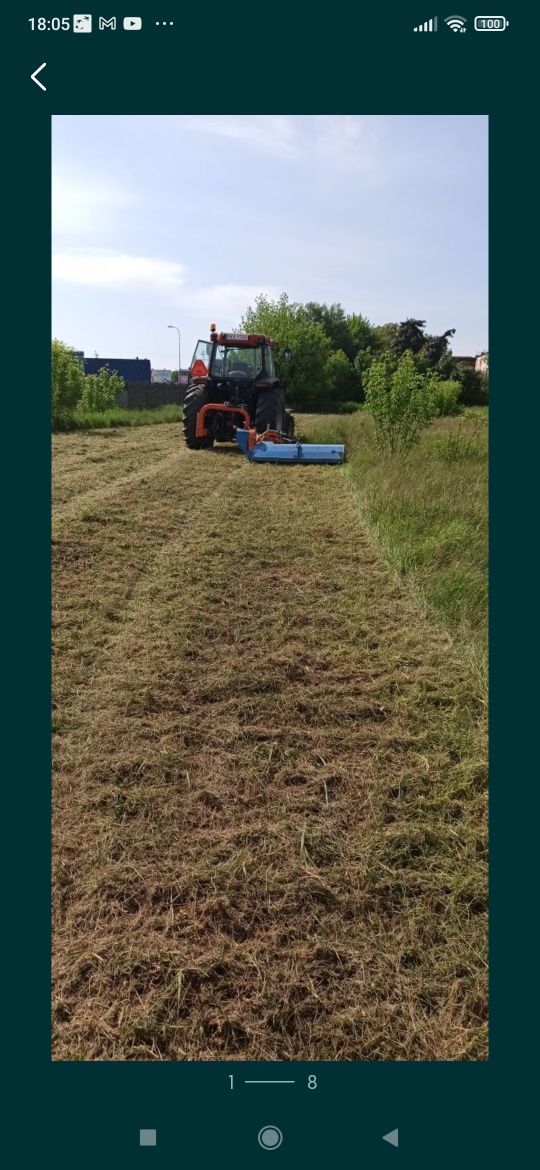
[184,325,295,450]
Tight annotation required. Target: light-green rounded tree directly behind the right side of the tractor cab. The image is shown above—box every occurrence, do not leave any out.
[242,293,332,411]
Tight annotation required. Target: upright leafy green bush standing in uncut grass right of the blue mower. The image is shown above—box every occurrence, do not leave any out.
[366,351,437,454]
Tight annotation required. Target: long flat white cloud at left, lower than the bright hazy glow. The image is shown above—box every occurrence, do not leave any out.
[53,248,186,295]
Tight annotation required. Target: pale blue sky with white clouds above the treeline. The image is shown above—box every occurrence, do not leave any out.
[53,115,487,369]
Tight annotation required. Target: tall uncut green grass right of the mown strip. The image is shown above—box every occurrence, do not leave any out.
[297,407,487,661]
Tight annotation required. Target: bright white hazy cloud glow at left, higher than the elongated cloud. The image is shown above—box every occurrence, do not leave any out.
[51,171,138,236]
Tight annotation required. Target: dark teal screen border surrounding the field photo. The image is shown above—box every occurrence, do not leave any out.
[6,4,532,1170]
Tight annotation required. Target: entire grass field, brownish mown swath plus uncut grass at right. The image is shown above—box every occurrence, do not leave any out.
[53,415,486,1060]
